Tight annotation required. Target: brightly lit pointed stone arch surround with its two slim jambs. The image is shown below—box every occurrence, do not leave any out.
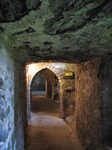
[27,63,63,120]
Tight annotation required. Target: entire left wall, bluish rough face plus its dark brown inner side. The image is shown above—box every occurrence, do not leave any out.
[0,34,27,150]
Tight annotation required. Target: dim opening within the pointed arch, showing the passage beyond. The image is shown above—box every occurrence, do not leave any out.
[30,68,60,115]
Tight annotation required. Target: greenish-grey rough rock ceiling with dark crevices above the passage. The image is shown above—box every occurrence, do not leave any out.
[0,0,112,61]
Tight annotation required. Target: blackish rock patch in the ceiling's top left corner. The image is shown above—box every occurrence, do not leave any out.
[0,0,40,22]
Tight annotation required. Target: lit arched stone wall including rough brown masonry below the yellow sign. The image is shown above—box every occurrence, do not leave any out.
[26,63,75,122]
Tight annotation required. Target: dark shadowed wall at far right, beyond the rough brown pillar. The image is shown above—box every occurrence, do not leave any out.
[102,57,112,146]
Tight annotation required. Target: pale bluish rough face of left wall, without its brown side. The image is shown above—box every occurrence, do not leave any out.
[0,38,16,150]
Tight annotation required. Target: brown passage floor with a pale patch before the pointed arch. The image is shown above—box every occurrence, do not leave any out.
[26,96,82,150]
